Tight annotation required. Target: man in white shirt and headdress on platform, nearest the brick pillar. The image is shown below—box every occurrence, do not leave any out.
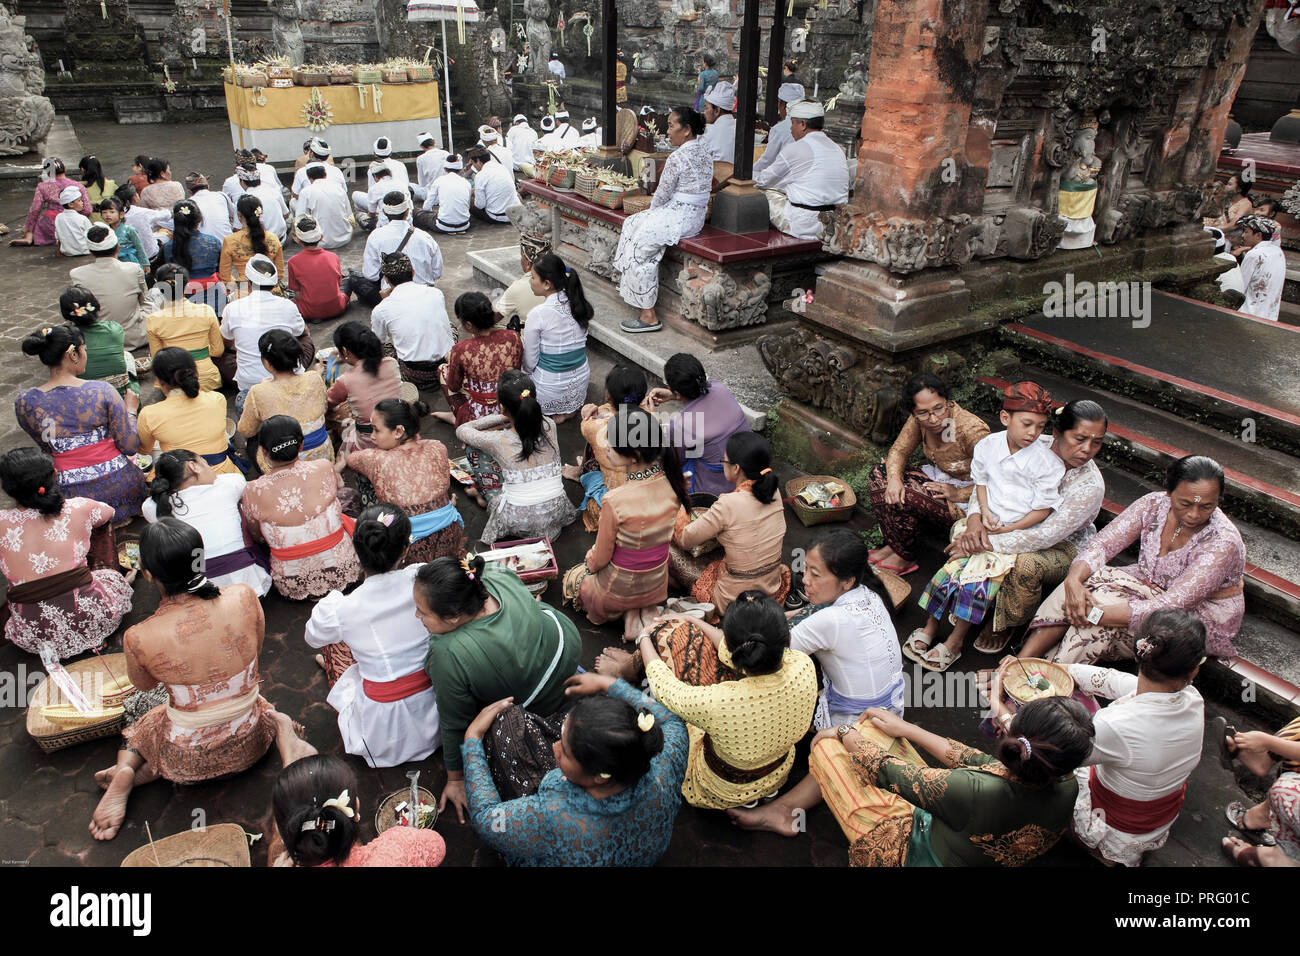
[755,100,849,239]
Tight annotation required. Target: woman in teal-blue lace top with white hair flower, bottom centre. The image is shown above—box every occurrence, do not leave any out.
[460,674,690,866]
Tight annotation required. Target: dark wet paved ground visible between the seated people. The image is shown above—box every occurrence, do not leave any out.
[0,122,1268,866]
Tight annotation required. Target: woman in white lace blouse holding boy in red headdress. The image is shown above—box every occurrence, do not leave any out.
[948,399,1110,654]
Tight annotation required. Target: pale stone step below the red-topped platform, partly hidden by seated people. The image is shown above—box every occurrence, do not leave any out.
[467,246,780,432]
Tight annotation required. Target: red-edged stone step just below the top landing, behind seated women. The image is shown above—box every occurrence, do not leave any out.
[982,364,1300,540]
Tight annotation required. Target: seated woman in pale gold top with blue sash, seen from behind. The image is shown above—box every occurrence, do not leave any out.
[238,329,334,472]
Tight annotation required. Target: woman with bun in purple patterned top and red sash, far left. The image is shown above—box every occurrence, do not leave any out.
[13,325,146,524]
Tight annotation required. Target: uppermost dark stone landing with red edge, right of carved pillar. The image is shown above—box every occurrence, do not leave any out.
[1002,291,1300,455]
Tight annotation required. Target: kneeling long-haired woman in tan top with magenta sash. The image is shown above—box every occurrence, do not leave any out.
[564,407,690,641]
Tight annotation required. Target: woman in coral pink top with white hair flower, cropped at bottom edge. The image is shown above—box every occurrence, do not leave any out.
[270,750,447,866]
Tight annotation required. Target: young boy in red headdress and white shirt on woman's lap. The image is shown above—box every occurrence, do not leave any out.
[902,381,1065,671]
